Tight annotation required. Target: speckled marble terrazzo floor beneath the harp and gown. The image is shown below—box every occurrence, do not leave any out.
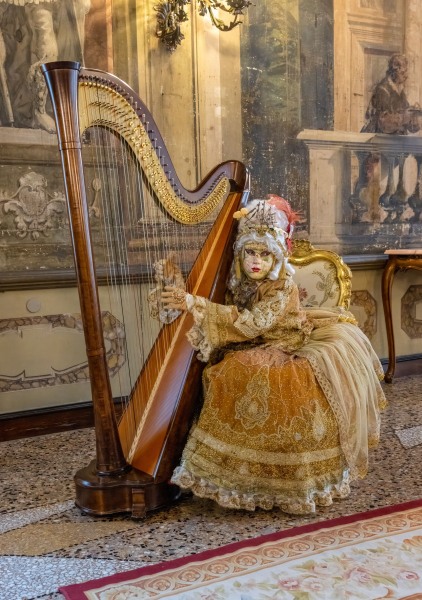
[0,375,422,600]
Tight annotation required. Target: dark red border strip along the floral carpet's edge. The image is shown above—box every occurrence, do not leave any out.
[58,499,422,600]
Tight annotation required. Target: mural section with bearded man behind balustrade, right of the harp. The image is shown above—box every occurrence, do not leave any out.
[242,0,422,255]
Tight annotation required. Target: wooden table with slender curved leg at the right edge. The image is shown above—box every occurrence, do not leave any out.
[382,248,422,383]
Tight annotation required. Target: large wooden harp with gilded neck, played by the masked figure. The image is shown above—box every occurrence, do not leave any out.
[42,62,249,518]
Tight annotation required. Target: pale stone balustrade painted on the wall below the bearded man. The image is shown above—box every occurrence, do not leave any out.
[298,129,422,254]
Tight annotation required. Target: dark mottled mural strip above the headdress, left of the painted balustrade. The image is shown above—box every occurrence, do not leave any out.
[241,1,334,230]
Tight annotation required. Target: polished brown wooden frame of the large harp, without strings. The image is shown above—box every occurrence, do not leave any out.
[42,62,249,518]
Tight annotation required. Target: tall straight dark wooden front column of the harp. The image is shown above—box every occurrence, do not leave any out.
[42,62,130,475]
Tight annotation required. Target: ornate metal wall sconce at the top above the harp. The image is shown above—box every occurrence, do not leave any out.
[154,0,252,52]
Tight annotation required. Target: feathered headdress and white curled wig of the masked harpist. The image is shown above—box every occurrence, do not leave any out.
[229,194,299,289]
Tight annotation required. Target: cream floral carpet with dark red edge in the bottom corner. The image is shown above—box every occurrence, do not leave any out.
[60,500,422,600]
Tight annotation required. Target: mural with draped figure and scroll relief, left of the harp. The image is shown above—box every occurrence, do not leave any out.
[0,0,112,276]
